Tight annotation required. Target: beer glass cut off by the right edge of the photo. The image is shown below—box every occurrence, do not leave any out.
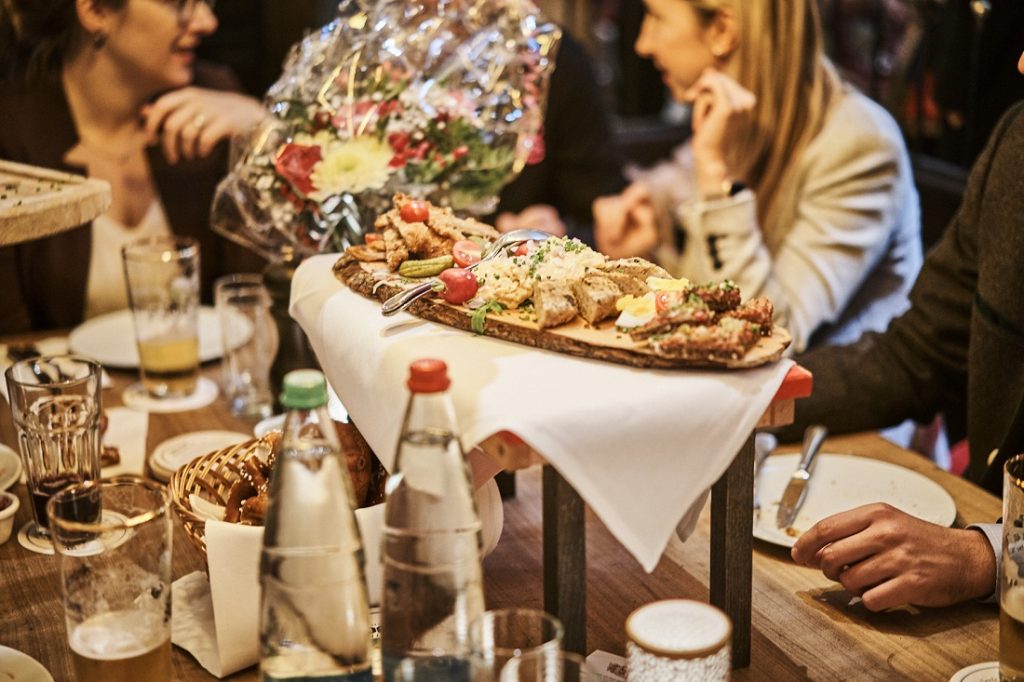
[997,455,1024,682]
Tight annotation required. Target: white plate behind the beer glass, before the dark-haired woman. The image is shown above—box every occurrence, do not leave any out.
[68,305,252,370]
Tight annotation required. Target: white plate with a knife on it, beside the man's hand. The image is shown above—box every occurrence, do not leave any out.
[754,453,956,547]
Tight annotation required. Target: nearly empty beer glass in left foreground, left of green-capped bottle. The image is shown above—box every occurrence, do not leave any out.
[46,476,172,682]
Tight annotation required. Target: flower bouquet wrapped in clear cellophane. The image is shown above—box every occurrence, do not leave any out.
[213,0,560,260]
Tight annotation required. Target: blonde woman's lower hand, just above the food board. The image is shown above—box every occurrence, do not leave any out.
[593,182,659,258]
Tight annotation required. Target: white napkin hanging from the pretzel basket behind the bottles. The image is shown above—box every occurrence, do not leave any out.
[171,480,504,678]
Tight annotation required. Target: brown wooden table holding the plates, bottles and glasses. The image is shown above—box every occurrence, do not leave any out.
[0,346,999,680]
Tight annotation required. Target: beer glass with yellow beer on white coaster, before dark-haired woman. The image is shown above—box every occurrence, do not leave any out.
[121,237,199,398]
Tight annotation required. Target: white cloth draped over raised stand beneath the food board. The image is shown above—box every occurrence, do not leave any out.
[291,254,793,571]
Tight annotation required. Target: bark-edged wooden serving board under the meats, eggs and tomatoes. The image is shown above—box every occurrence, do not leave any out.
[334,261,791,370]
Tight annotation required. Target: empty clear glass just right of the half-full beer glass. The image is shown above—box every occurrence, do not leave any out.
[213,273,278,417]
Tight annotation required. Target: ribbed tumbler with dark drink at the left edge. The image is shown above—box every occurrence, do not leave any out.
[6,355,102,547]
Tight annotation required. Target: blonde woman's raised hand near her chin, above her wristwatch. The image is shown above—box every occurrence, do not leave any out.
[685,69,757,197]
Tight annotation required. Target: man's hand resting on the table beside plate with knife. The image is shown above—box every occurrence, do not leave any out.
[792,503,995,611]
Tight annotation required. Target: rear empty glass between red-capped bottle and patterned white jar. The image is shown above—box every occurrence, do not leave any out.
[469,608,565,675]
